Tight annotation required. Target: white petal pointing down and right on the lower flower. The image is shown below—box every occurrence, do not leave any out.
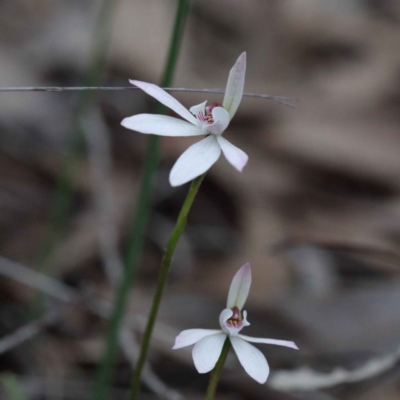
[230,336,269,383]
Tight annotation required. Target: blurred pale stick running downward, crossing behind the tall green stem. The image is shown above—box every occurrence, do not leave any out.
[82,111,183,400]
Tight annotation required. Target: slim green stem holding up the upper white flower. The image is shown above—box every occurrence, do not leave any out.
[130,174,205,400]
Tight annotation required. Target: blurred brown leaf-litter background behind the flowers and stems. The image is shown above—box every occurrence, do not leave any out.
[0,0,400,400]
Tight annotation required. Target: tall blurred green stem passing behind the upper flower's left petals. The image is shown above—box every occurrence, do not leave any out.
[93,0,189,400]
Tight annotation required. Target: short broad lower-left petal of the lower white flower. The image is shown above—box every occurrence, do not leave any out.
[192,333,227,374]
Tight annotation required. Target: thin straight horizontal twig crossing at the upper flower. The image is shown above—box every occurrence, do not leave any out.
[0,86,297,107]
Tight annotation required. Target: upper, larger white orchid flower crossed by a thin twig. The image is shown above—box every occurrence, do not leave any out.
[121,53,248,186]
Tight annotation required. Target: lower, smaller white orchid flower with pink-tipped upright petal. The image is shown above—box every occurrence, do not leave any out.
[173,264,298,383]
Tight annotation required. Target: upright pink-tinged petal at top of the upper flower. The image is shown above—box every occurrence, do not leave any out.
[222,53,246,119]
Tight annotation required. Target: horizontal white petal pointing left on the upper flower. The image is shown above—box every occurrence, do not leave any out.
[121,114,203,136]
